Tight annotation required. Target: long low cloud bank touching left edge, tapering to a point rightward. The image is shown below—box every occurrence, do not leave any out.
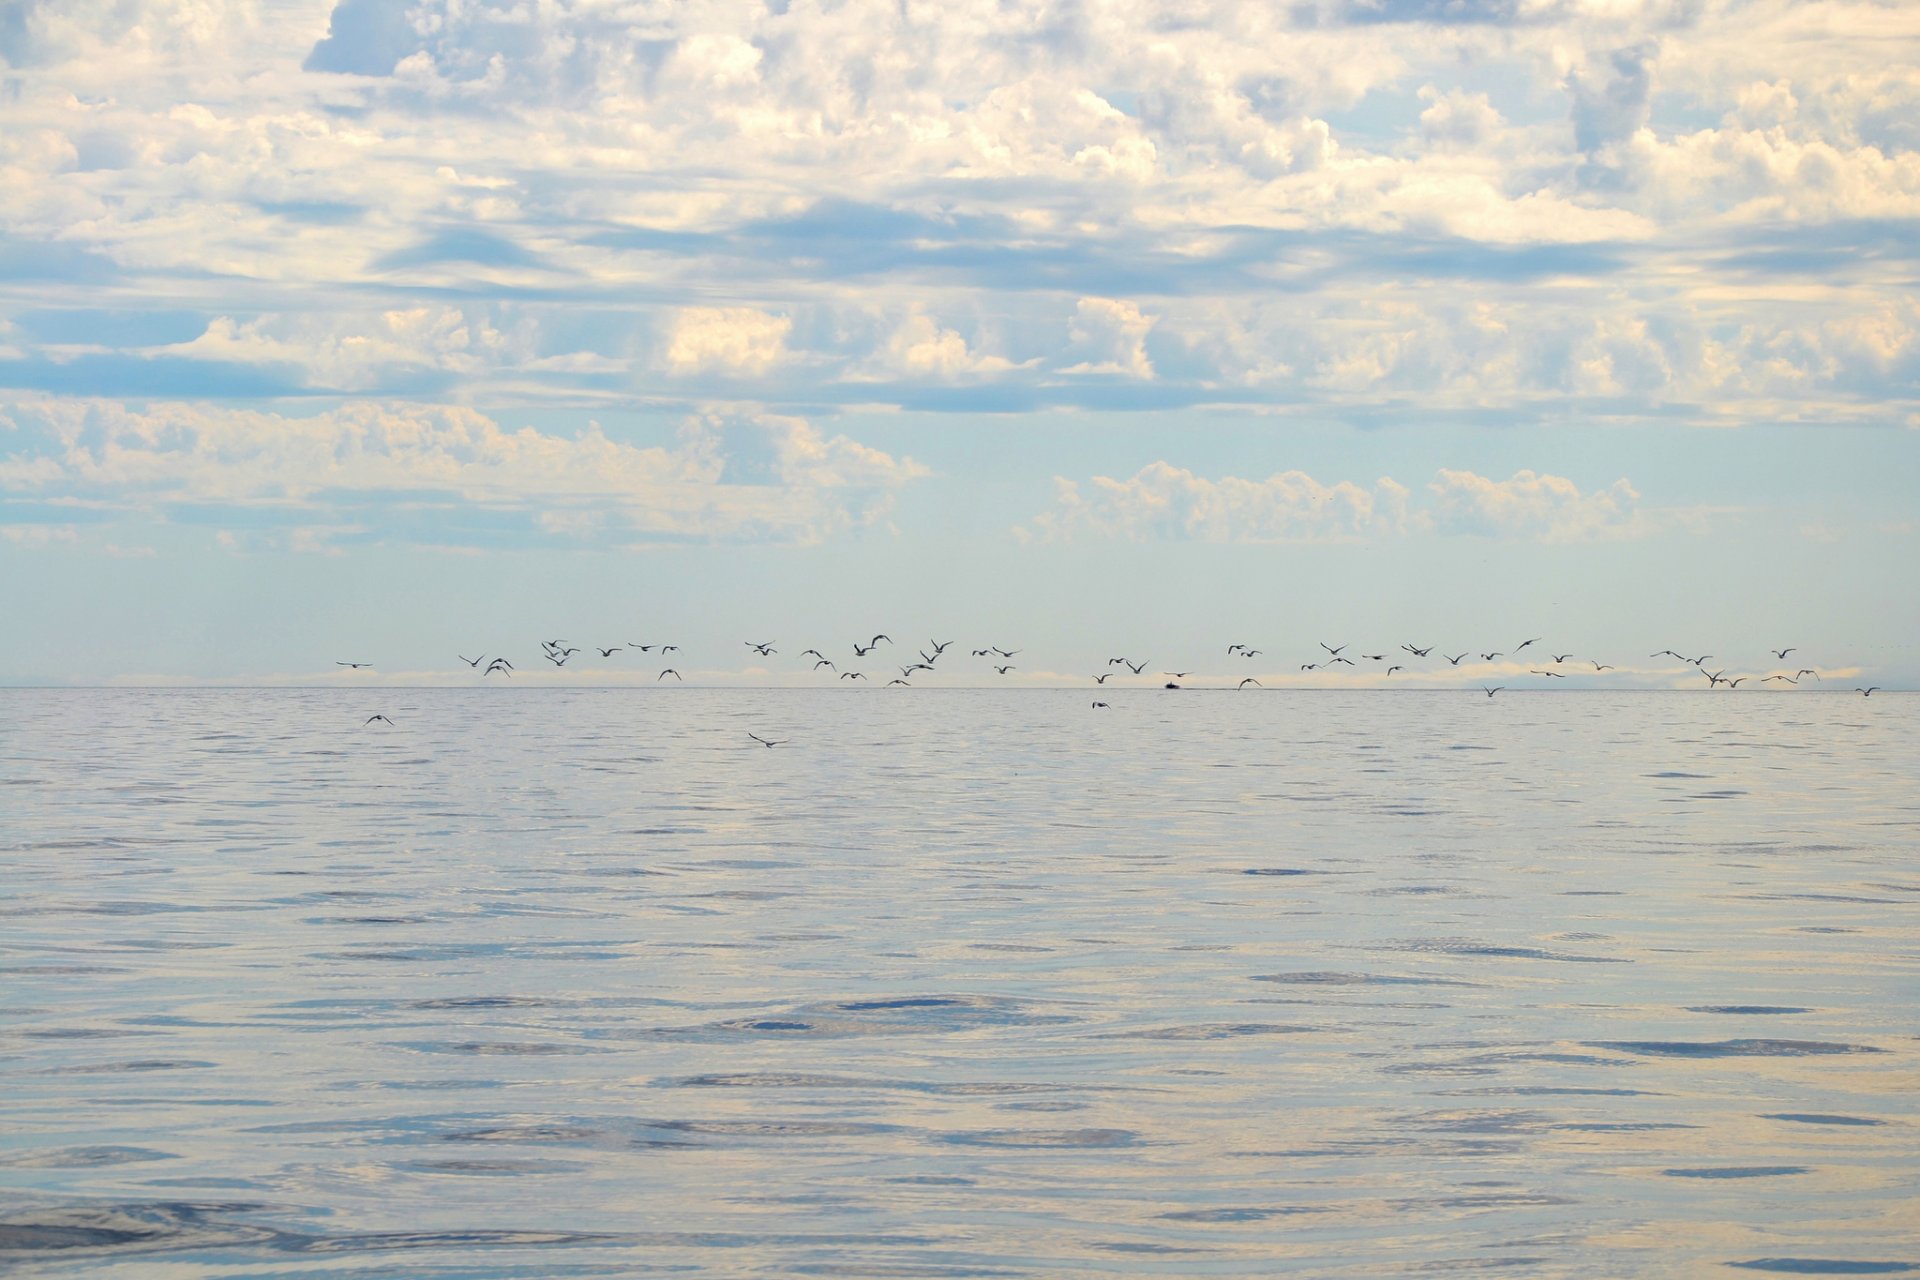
[0,401,925,543]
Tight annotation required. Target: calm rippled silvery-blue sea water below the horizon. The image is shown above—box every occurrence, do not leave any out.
[0,689,1920,1280]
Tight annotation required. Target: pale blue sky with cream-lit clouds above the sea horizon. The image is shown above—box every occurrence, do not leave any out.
[0,0,1920,691]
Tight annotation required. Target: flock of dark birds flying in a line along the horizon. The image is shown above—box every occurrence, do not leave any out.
[334,633,1880,747]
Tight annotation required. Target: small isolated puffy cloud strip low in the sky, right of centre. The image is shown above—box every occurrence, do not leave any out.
[1016,462,1655,543]
